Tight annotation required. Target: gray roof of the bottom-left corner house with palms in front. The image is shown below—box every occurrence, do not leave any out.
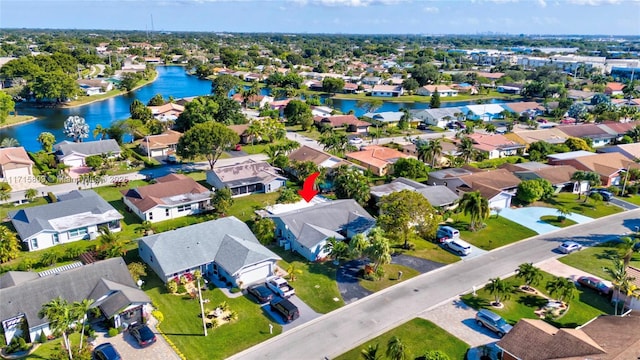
[0,257,146,328]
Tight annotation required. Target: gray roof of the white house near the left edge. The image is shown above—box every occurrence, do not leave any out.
[9,190,123,240]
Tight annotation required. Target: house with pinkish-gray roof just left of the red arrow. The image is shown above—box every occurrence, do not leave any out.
[207,160,287,196]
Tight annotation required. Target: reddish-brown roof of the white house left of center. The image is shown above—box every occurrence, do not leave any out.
[121,174,209,212]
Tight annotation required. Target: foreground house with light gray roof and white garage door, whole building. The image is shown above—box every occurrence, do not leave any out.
[138,216,281,288]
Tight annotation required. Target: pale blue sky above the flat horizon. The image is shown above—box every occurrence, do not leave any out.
[0,0,640,35]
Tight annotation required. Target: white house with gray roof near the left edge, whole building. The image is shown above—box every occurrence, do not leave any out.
[8,190,124,251]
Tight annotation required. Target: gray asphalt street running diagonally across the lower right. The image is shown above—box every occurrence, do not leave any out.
[230,210,640,360]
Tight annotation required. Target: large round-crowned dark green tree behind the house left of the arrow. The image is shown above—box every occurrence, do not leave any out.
[177,122,240,170]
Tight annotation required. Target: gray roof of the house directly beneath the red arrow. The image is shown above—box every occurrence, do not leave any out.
[271,199,375,246]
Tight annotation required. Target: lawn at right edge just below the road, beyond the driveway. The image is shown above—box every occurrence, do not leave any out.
[558,242,640,280]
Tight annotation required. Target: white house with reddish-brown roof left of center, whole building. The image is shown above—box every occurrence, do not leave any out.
[120,174,211,222]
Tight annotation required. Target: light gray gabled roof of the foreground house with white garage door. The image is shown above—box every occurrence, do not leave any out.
[139,216,280,275]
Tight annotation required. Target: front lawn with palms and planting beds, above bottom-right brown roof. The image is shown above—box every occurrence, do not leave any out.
[462,271,614,328]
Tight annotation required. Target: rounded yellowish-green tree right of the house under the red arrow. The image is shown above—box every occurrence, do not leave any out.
[378,190,439,248]
